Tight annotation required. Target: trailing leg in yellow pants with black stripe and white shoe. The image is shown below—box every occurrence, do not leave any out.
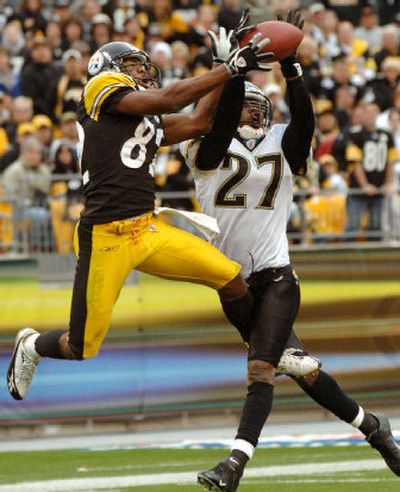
[7,223,131,399]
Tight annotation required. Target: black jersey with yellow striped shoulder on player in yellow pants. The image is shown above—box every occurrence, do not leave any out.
[78,72,163,224]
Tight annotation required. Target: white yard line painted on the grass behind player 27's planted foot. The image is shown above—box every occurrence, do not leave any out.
[0,460,386,492]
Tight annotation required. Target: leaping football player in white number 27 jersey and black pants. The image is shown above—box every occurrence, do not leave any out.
[182,11,400,492]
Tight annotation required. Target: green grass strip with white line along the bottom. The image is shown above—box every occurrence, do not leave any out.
[0,448,400,492]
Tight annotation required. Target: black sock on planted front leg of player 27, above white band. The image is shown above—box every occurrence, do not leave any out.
[236,381,274,447]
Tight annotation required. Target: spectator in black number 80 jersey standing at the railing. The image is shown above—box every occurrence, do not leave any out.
[346,103,398,240]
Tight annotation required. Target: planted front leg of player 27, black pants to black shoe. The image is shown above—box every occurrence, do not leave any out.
[199,266,300,492]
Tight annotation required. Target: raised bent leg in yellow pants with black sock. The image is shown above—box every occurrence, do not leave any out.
[137,219,253,340]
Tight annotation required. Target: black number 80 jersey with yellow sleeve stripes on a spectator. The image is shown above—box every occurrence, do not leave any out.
[346,129,396,188]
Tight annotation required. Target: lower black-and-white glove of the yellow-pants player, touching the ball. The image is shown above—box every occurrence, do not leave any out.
[225,33,275,77]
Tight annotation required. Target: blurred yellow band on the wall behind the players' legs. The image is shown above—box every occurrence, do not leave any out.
[0,275,400,332]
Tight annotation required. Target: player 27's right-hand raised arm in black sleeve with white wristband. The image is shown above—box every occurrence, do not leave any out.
[278,10,314,174]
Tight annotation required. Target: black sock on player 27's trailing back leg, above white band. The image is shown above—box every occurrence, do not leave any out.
[297,371,359,424]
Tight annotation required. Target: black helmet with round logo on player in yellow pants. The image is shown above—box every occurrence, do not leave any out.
[88,41,161,89]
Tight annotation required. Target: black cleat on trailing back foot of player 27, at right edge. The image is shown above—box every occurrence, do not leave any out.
[368,413,400,476]
